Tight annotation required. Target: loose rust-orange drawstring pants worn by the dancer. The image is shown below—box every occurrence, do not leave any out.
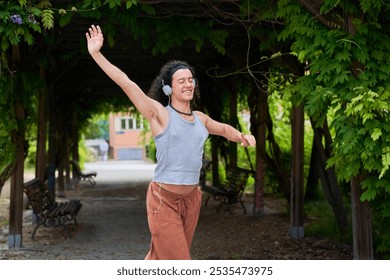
[145,182,202,260]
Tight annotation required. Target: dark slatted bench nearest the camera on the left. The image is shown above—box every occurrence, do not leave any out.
[23,179,82,239]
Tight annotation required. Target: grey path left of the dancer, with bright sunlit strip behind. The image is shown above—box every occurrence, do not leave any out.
[0,161,155,259]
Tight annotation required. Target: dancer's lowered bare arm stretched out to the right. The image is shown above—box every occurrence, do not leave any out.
[196,111,256,147]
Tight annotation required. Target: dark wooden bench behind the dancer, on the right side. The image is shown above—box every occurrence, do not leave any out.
[201,167,255,214]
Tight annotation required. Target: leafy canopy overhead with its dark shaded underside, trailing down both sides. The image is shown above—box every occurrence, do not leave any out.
[0,0,390,258]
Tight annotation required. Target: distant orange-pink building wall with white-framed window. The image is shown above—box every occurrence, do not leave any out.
[109,111,150,160]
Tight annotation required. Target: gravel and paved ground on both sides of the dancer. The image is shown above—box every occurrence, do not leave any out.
[0,162,352,260]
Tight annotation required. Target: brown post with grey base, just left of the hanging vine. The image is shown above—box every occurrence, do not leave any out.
[290,105,304,239]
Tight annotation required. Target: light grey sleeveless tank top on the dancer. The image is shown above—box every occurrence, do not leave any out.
[153,106,209,185]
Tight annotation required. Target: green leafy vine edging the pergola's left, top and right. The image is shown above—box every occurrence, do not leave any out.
[0,0,390,258]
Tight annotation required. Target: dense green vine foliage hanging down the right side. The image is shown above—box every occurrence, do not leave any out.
[277,0,390,253]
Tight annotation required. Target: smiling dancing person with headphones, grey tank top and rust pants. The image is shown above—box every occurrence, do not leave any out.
[86,25,256,260]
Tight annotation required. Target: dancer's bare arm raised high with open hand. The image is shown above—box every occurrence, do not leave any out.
[85,25,163,122]
